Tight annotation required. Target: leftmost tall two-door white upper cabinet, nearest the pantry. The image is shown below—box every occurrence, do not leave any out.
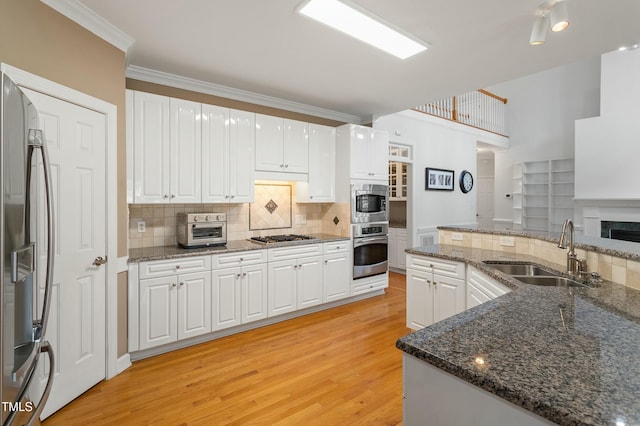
[129,92,201,203]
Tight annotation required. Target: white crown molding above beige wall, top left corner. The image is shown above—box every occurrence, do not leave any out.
[40,0,135,53]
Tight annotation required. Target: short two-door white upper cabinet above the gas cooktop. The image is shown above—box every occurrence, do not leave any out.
[255,114,309,174]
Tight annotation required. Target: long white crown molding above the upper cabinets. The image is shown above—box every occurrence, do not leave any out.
[127,65,364,124]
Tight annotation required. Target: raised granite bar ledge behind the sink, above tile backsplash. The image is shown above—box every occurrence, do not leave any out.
[438,225,640,261]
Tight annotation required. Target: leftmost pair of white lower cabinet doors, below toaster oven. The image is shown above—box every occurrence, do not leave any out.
[139,271,211,349]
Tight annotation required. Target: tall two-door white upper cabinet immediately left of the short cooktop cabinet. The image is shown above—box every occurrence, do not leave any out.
[202,105,255,203]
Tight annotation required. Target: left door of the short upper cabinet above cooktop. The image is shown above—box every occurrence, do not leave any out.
[255,114,284,172]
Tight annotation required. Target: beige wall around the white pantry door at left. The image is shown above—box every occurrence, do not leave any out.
[0,0,127,356]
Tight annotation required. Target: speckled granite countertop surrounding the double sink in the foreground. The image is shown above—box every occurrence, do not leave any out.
[396,245,640,425]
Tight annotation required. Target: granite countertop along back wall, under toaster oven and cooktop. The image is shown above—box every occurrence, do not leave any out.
[129,234,349,263]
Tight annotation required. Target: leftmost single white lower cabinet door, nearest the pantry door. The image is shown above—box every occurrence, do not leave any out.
[139,275,178,349]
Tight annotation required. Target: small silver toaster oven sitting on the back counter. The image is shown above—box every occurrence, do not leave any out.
[176,213,227,248]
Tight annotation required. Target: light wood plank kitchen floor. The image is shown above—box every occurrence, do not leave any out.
[43,273,410,426]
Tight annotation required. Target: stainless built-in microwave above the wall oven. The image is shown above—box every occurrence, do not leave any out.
[351,183,389,223]
